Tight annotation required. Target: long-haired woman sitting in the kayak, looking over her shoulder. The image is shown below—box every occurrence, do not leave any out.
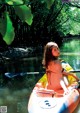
[42,42,79,93]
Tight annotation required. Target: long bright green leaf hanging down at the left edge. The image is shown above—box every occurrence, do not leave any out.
[0,12,15,45]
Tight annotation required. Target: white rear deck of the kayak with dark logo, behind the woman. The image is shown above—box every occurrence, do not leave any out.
[28,85,80,113]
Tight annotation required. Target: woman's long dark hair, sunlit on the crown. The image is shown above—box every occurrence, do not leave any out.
[42,42,58,68]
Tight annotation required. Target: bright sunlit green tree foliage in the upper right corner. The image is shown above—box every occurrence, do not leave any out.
[58,0,80,36]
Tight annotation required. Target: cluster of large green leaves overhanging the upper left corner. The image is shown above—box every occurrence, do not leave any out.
[0,0,33,45]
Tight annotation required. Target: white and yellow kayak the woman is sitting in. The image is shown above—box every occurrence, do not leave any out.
[28,61,80,113]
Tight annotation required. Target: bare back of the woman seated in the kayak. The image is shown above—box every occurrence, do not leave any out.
[46,60,62,90]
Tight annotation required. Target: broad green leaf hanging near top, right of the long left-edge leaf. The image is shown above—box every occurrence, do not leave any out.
[14,5,33,25]
